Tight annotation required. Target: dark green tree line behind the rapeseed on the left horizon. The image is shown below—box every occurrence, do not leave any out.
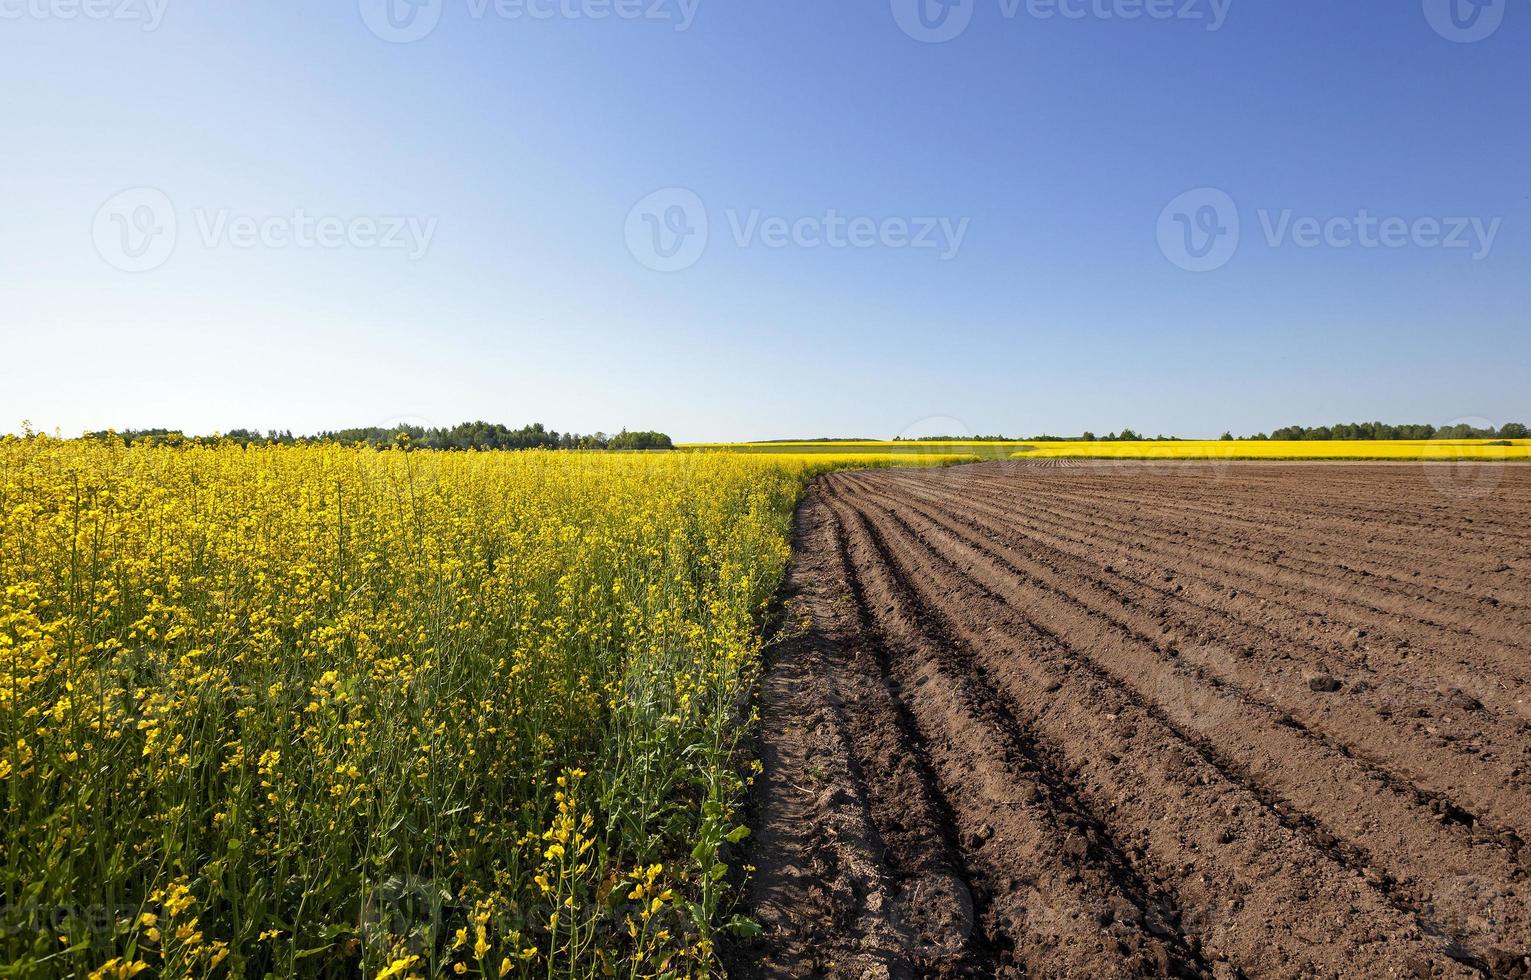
[87,421,675,450]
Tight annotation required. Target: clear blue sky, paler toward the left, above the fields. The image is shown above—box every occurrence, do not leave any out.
[0,0,1531,441]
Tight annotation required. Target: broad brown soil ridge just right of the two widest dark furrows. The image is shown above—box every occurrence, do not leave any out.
[832,471,1488,975]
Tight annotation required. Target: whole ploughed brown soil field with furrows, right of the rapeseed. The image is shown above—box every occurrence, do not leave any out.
[729,462,1531,978]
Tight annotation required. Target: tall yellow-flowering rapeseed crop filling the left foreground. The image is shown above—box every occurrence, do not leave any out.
[0,436,940,980]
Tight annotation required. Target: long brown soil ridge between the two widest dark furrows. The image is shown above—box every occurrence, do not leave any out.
[837,493,1211,977]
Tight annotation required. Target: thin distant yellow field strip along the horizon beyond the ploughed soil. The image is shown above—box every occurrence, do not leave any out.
[681,439,1531,466]
